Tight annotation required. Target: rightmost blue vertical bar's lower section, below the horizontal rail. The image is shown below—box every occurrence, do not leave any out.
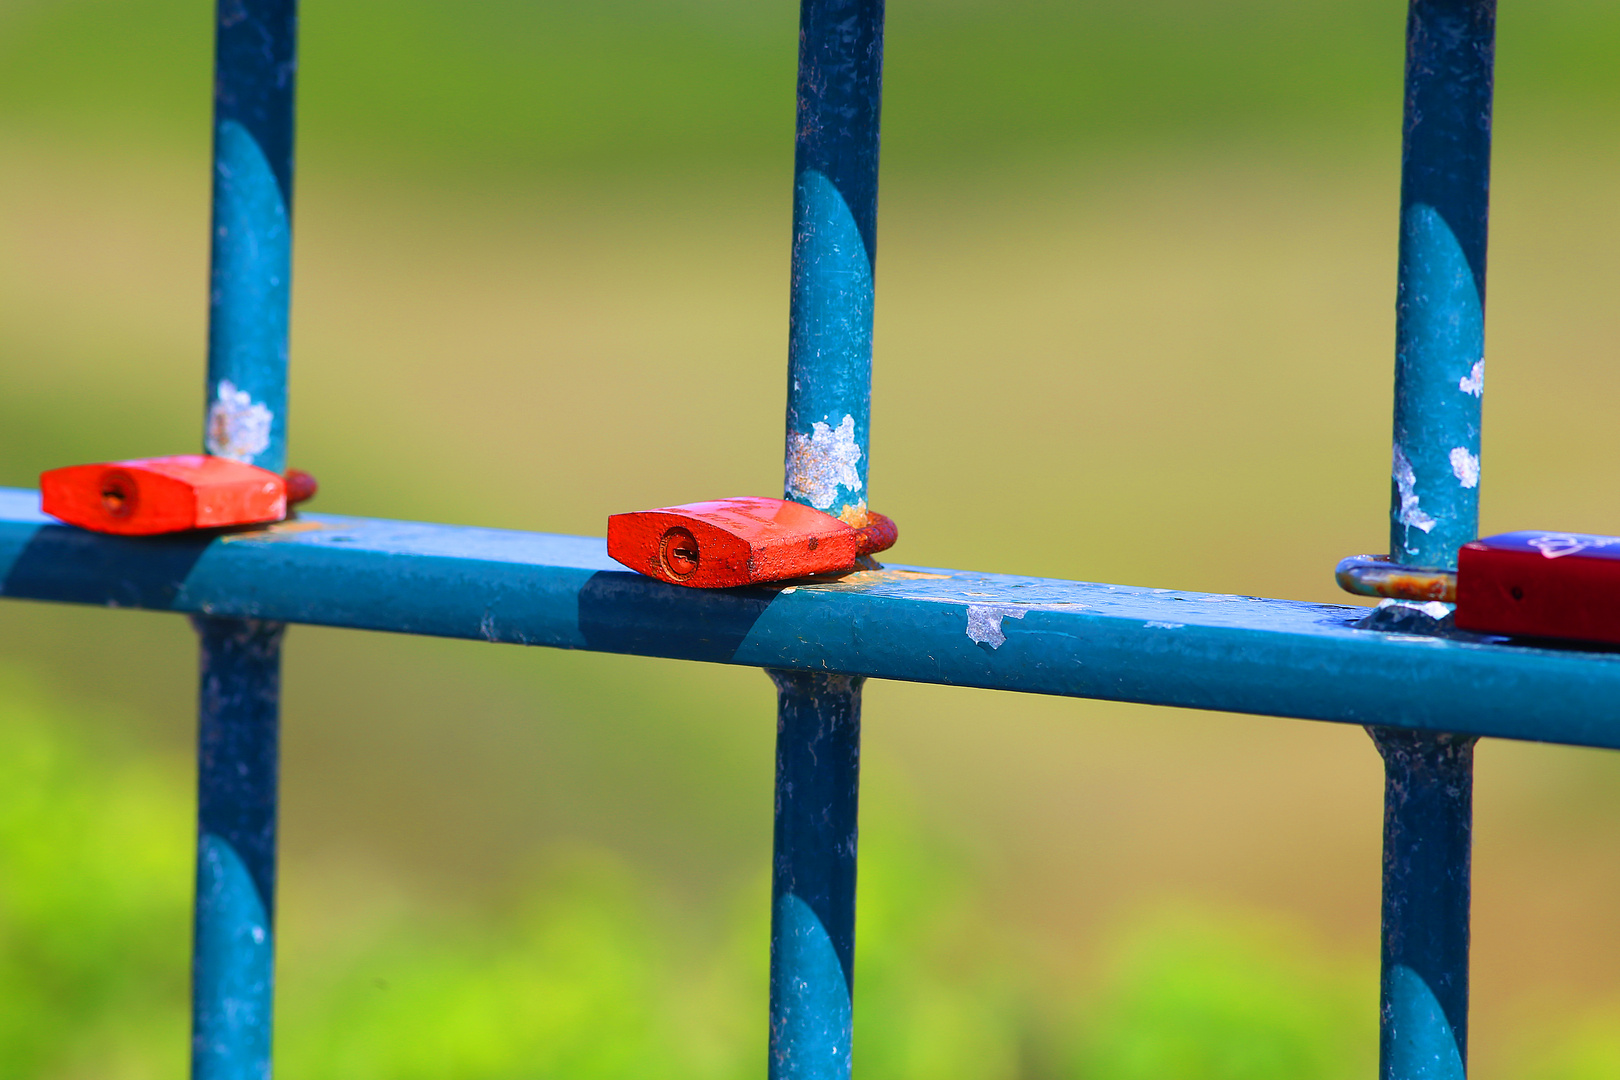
[1371,727,1474,1080]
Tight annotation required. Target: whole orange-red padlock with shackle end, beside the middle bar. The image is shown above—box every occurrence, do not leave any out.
[608,497,897,589]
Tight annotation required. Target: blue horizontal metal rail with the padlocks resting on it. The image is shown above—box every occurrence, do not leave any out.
[12,489,1620,748]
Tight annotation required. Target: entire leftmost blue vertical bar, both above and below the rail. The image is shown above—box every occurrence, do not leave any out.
[191,0,298,1080]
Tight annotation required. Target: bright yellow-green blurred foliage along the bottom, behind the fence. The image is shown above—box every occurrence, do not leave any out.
[0,669,1371,1080]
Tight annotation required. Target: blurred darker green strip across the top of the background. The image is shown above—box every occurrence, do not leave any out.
[9,0,1620,180]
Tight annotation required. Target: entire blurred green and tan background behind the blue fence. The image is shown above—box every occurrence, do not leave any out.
[0,0,1620,1080]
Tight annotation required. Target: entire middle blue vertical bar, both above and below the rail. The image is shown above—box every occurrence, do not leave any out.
[770,0,883,1080]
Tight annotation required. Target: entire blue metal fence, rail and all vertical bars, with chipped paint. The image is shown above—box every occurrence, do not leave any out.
[0,0,1620,1080]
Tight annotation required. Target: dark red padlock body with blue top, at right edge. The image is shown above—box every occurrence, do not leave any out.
[1455,531,1620,644]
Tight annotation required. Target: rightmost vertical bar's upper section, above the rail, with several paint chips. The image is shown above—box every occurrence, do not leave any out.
[1390,0,1497,570]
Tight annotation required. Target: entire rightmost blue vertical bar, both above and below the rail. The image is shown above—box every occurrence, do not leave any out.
[1369,0,1495,1080]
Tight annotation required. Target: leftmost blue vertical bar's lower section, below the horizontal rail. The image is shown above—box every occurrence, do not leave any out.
[191,617,284,1080]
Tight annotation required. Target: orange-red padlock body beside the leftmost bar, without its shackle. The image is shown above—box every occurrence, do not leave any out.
[39,453,287,536]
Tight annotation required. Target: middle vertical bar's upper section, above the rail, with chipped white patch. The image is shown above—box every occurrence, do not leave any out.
[784,0,883,526]
